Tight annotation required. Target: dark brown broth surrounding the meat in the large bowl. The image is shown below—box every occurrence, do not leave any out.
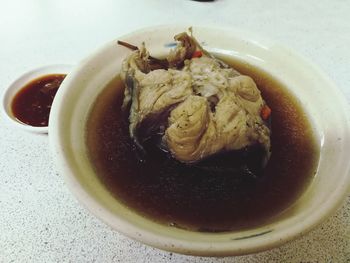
[87,60,319,232]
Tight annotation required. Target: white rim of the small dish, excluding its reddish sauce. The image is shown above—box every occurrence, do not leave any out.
[2,64,73,133]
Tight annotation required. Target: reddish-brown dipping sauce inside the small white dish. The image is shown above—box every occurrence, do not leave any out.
[11,74,66,127]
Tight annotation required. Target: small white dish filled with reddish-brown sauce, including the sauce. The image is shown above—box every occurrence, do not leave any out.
[2,64,73,133]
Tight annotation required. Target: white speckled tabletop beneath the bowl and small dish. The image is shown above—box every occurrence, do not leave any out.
[0,0,350,262]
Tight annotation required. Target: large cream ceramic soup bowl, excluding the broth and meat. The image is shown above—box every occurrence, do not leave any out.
[49,26,350,256]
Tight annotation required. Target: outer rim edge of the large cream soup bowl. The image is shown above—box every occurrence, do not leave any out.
[49,25,350,256]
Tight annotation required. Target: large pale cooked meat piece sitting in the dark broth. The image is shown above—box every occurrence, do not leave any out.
[121,30,270,163]
